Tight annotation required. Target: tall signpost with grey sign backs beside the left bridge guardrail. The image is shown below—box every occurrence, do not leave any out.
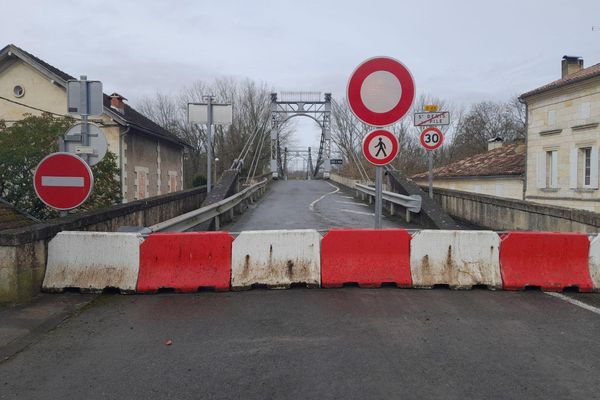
[188,100,233,193]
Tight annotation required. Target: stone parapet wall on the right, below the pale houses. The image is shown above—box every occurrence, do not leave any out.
[434,188,600,233]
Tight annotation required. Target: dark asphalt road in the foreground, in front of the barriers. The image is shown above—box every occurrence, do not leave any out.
[0,288,600,400]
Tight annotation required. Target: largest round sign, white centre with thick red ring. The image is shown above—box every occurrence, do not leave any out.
[346,57,415,126]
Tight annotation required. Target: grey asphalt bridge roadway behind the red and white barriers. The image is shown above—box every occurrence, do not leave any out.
[223,180,417,232]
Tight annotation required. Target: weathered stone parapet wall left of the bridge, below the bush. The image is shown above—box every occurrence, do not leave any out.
[0,187,206,303]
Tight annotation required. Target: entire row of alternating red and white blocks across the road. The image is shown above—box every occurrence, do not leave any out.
[43,229,600,293]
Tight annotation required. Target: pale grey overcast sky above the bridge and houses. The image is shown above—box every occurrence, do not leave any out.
[0,0,600,148]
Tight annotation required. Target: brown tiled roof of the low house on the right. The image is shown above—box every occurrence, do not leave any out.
[411,144,525,179]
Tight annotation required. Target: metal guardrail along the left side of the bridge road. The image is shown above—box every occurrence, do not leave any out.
[143,179,267,234]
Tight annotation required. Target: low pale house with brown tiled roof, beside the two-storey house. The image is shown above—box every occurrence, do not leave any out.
[411,139,525,200]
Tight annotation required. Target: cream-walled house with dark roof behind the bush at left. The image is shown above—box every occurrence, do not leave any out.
[0,44,186,202]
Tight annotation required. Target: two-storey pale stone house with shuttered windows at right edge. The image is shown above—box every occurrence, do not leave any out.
[520,56,600,212]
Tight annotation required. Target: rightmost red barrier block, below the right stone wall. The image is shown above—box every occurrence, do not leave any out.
[500,232,592,292]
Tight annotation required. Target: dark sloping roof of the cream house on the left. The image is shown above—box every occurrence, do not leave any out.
[0,44,188,146]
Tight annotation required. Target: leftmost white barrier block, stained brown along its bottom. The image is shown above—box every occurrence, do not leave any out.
[42,232,143,293]
